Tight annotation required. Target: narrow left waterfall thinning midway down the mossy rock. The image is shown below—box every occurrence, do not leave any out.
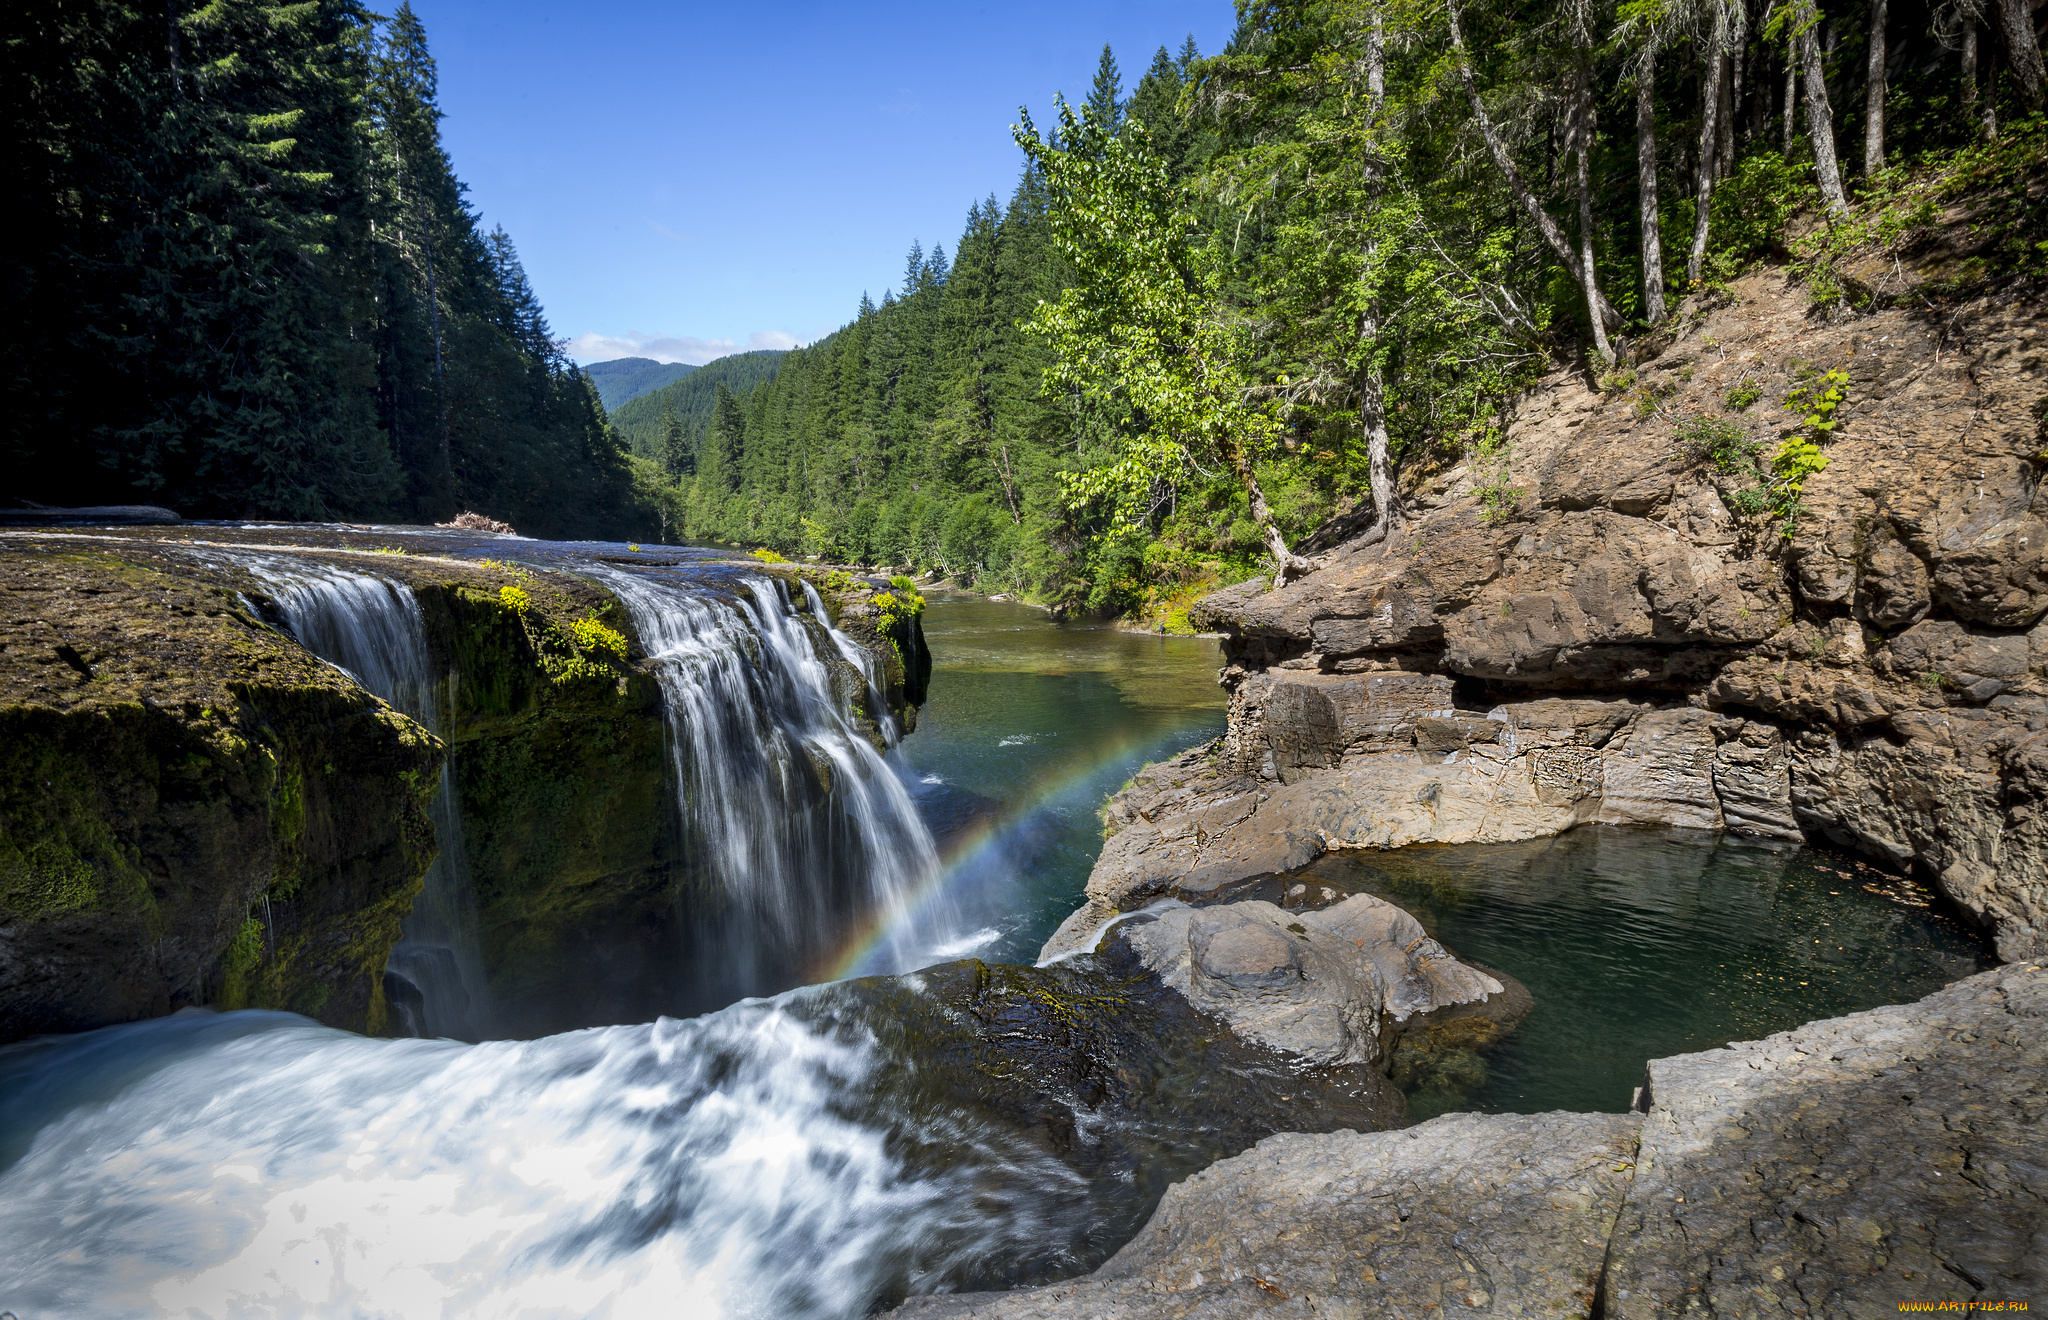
[236,555,489,1040]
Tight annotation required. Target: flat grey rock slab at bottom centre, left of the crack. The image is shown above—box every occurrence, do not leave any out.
[893,1113,1640,1320]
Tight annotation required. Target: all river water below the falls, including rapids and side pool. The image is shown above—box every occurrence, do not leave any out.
[0,552,1982,1320]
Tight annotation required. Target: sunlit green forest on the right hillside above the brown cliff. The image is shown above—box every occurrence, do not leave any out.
[647,0,2048,620]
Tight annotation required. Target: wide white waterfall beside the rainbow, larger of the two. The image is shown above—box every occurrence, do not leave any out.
[592,567,942,1007]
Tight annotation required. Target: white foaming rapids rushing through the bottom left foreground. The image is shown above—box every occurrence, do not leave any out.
[0,991,1085,1320]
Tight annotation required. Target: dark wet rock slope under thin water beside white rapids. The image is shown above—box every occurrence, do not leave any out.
[786,950,1407,1302]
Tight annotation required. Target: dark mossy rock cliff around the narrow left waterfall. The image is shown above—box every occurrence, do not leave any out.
[0,528,922,1040]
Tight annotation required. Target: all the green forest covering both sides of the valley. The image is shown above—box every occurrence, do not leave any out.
[4,0,2048,605]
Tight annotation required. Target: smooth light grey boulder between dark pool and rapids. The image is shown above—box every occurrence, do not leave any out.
[1104,894,1526,1066]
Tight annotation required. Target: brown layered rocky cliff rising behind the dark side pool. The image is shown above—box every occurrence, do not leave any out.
[1047,266,2048,960]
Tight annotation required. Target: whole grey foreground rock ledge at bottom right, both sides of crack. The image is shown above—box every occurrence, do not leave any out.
[893,964,2048,1320]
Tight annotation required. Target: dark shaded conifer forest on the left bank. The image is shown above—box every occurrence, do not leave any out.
[0,0,645,534]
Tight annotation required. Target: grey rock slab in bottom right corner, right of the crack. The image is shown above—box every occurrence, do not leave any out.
[1606,964,2048,1320]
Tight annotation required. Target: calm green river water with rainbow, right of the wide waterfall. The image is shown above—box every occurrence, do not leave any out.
[901,591,1225,962]
